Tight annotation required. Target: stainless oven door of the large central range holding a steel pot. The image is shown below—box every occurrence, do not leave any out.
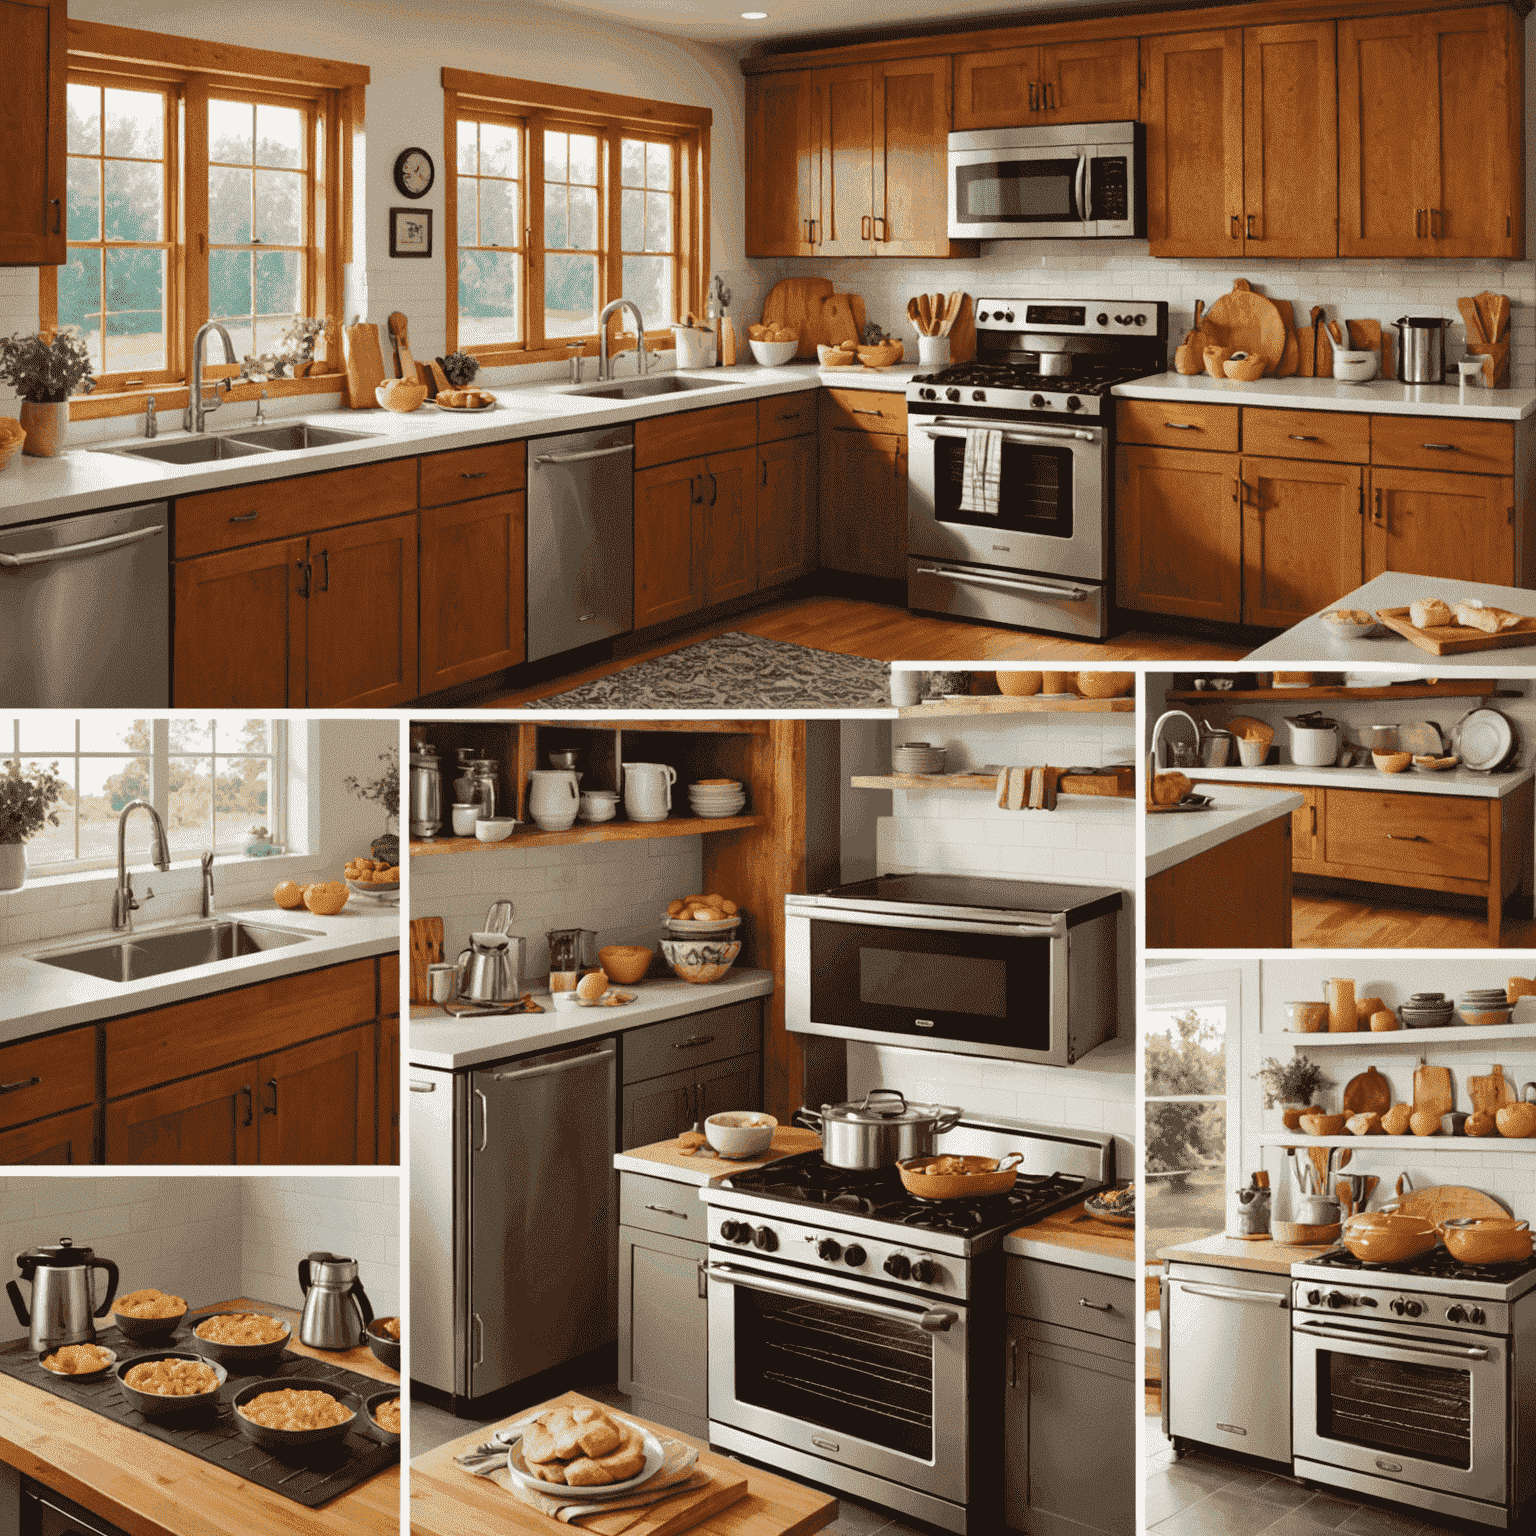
[708,1250,969,1504]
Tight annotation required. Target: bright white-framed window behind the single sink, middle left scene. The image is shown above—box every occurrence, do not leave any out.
[0,711,287,876]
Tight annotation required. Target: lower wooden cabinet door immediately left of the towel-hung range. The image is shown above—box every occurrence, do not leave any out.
[820,432,906,578]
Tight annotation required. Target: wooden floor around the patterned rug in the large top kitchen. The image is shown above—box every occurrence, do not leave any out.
[479,598,1246,710]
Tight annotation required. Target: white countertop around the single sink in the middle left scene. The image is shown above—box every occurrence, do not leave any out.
[0,900,399,1044]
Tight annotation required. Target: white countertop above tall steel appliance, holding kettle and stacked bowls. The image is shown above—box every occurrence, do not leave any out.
[407,968,773,1072]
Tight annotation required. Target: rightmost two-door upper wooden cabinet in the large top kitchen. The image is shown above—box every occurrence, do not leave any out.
[1338,5,1525,260]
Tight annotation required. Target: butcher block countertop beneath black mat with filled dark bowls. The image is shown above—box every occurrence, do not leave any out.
[0,1296,401,1536]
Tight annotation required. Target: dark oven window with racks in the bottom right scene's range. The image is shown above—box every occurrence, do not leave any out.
[1318,1350,1471,1468]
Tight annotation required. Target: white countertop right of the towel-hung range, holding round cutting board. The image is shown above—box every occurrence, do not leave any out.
[1112,373,1536,421]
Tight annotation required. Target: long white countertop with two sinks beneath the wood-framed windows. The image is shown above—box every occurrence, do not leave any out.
[0,362,897,528]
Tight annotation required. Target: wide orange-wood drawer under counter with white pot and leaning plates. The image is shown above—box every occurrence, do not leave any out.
[1322,790,1499,880]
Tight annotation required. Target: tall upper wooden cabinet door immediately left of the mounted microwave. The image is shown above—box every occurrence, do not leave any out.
[871,57,949,257]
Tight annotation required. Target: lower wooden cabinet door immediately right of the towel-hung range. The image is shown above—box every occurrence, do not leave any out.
[1115,449,1243,624]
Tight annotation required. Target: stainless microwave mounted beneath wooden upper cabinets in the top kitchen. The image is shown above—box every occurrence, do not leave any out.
[949,123,1147,240]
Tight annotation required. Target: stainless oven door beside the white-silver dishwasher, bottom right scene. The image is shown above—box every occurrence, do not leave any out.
[1290,1316,1508,1504]
